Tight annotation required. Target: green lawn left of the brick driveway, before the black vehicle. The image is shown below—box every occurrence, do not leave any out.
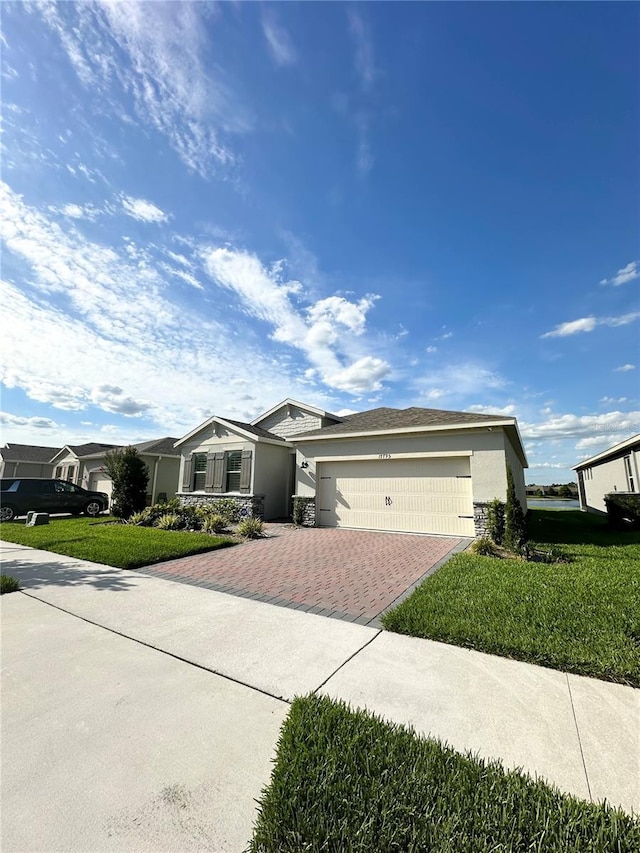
[0,518,235,569]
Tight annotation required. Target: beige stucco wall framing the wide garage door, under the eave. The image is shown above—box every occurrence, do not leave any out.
[296,427,524,501]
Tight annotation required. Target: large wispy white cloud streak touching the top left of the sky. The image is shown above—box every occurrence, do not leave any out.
[37,0,250,176]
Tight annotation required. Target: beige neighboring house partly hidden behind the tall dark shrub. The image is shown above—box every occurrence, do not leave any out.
[52,437,180,503]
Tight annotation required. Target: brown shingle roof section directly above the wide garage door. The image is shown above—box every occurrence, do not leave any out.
[295,406,513,441]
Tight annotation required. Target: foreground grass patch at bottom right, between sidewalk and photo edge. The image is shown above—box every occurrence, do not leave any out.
[249,697,640,853]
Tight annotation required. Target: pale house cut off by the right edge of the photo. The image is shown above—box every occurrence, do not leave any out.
[573,434,640,513]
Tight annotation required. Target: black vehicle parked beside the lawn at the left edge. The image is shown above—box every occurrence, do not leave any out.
[0,477,109,521]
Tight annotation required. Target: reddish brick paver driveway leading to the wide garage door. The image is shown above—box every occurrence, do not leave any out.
[142,524,467,624]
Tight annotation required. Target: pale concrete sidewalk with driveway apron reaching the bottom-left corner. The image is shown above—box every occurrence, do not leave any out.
[2,544,640,853]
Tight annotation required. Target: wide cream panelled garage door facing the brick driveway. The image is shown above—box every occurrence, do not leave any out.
[317,457,475,536]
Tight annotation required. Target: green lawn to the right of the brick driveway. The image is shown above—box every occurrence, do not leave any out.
[382,510,640,687]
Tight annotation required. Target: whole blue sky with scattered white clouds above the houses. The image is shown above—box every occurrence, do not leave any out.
[0,2,640,483]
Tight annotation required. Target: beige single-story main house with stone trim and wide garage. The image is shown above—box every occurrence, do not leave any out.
[176,400,527,536]
